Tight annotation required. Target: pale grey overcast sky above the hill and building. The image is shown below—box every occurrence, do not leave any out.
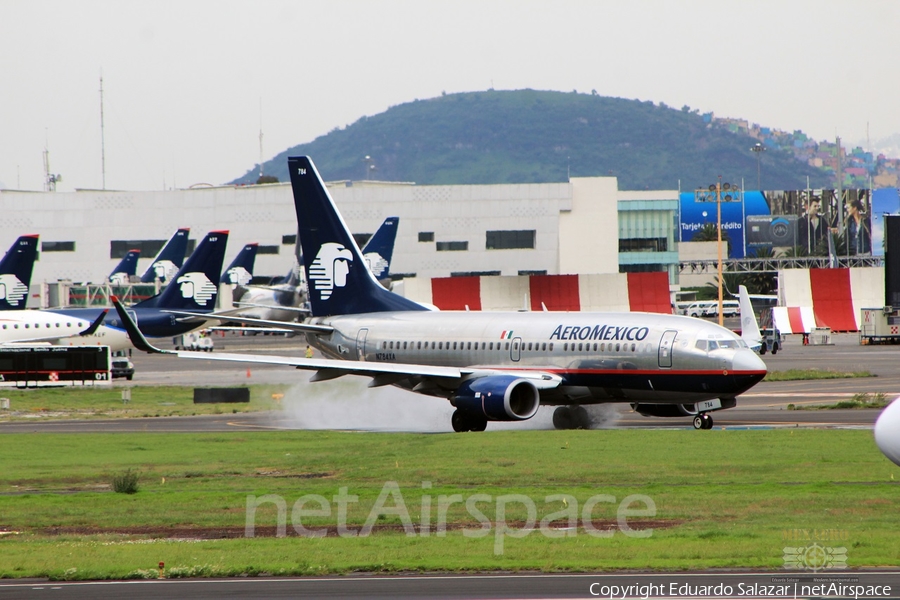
[0,0,900,190]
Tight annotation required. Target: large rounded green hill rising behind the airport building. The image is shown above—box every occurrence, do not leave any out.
[233,90,832,190]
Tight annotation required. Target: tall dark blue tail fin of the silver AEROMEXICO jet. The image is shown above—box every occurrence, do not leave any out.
[288,156,427,317]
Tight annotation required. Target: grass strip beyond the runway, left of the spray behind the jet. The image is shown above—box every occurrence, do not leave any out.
[0,385,288,421]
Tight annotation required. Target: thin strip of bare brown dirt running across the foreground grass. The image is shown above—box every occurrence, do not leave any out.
[30,519,684,540]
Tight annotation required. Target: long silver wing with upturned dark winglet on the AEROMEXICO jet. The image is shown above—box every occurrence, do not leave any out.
[113,297,562,389]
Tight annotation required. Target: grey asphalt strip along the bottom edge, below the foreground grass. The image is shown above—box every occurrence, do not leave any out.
[0,571,900,600]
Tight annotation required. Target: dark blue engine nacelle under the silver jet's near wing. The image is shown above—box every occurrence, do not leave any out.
[450,375,541,421]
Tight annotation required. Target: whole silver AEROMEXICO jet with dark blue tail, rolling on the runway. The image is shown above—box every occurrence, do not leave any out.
[115,157,766,431]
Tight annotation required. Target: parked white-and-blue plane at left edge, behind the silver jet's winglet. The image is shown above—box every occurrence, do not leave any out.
[0,231,228,351]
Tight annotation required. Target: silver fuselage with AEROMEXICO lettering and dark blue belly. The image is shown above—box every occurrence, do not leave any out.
[308,311,766,404]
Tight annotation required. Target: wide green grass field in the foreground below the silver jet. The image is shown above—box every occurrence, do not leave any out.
[0,429,900,579]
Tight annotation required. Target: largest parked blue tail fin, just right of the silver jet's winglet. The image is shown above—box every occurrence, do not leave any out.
[135,231,228,311]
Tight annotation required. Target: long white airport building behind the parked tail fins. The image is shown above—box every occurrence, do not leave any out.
[0,177,678,296]
